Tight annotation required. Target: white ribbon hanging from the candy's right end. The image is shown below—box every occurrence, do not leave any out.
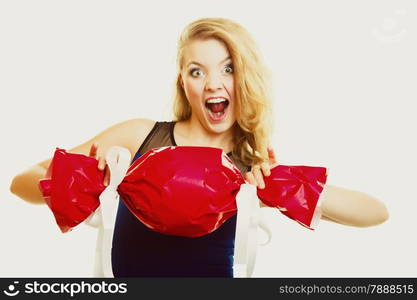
[233,183,272,277]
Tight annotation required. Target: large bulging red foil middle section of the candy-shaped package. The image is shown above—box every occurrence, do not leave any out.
[118,146,244,237]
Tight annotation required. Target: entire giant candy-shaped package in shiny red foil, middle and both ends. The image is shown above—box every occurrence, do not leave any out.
[39,146,326,237]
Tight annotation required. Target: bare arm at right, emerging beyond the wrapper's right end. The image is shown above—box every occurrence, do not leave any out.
[321,184,389,227]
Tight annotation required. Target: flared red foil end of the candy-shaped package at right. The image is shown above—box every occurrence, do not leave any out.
[257,165,327,229]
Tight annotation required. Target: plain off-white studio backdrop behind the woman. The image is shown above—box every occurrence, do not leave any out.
[0,0,417,277]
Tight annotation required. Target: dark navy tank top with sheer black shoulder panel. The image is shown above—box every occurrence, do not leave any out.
[112,121,249,277]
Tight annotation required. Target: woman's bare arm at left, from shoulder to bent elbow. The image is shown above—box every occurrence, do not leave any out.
[10,119,155,204]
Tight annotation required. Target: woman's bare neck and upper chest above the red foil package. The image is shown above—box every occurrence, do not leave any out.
[174,118,233,153]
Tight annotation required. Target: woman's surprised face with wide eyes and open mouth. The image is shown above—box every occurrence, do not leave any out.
[181,39,236,133]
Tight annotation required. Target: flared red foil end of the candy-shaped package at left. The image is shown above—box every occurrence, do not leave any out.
[39,148,105,232]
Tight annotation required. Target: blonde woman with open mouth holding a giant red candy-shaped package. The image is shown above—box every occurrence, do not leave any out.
[11,18,388,277]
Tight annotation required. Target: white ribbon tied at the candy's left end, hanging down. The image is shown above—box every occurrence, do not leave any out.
[86,146,131,277]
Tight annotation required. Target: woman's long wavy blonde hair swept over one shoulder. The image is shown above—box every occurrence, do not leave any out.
[173,18,272,166]
